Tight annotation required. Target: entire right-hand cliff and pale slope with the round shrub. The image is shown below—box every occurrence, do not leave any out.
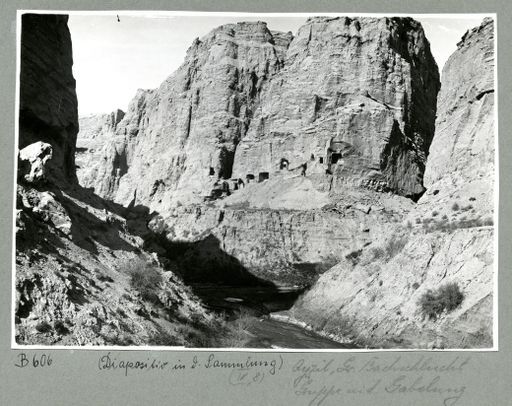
[290,19,495,348]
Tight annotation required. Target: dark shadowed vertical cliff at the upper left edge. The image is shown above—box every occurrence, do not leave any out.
[19,14,78,182]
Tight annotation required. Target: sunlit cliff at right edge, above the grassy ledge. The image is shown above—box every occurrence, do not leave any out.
[422,19,496,217]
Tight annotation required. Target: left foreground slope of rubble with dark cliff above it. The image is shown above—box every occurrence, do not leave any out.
[13,14,244,346]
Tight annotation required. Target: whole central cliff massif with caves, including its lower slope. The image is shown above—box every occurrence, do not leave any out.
[79,17,439,284]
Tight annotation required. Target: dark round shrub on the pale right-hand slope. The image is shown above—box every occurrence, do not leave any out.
[418,282,464,320]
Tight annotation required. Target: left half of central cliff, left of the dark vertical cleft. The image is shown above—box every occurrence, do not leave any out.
[77,22,292,207]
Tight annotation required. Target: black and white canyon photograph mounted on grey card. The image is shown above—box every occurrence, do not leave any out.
[15,10,498,352]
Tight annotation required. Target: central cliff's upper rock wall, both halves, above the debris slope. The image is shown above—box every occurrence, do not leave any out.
[81,17,439,212]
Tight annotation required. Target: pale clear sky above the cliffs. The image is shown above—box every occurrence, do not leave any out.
[68,14,484,116]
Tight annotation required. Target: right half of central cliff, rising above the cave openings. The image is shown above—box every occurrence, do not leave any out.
[234,17,439,200]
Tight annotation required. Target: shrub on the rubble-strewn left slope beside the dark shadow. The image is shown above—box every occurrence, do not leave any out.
[122,259,162,302]
